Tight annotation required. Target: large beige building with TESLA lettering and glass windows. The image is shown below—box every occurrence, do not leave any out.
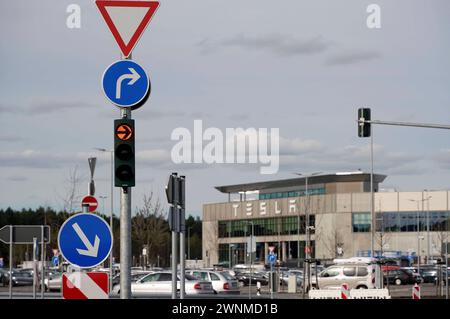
[203,171,450,266]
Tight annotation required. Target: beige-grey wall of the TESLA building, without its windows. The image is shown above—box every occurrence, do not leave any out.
[203,191,450,266]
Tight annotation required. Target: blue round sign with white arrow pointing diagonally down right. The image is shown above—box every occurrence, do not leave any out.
[58,213,112,268]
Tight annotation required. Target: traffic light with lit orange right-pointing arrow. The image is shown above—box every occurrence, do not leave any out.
[114,119,135,187]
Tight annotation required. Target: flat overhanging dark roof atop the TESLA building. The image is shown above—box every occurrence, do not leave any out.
[215,172,387,193]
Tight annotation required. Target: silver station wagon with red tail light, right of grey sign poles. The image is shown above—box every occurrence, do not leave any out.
[187,270,240,295]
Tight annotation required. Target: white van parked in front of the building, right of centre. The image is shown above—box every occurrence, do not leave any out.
[311,263,375,289]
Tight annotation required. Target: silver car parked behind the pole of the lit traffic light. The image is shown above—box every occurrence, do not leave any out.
[114,271,214,296]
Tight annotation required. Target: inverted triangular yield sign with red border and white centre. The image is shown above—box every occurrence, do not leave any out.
[95,0,159,58]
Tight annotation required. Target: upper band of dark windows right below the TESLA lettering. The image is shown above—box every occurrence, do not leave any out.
[219,215,315,238]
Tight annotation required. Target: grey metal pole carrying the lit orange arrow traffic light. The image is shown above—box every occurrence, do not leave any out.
[120,109,134,299]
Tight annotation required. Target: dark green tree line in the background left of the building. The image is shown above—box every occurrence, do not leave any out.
[0,199,202,267]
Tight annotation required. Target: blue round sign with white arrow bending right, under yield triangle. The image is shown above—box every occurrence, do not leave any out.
[102,60,150,109]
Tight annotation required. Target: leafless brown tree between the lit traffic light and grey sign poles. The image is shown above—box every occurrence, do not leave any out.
[132,192,169,263]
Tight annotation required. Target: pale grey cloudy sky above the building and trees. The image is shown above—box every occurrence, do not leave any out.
[0,0,450,215]
